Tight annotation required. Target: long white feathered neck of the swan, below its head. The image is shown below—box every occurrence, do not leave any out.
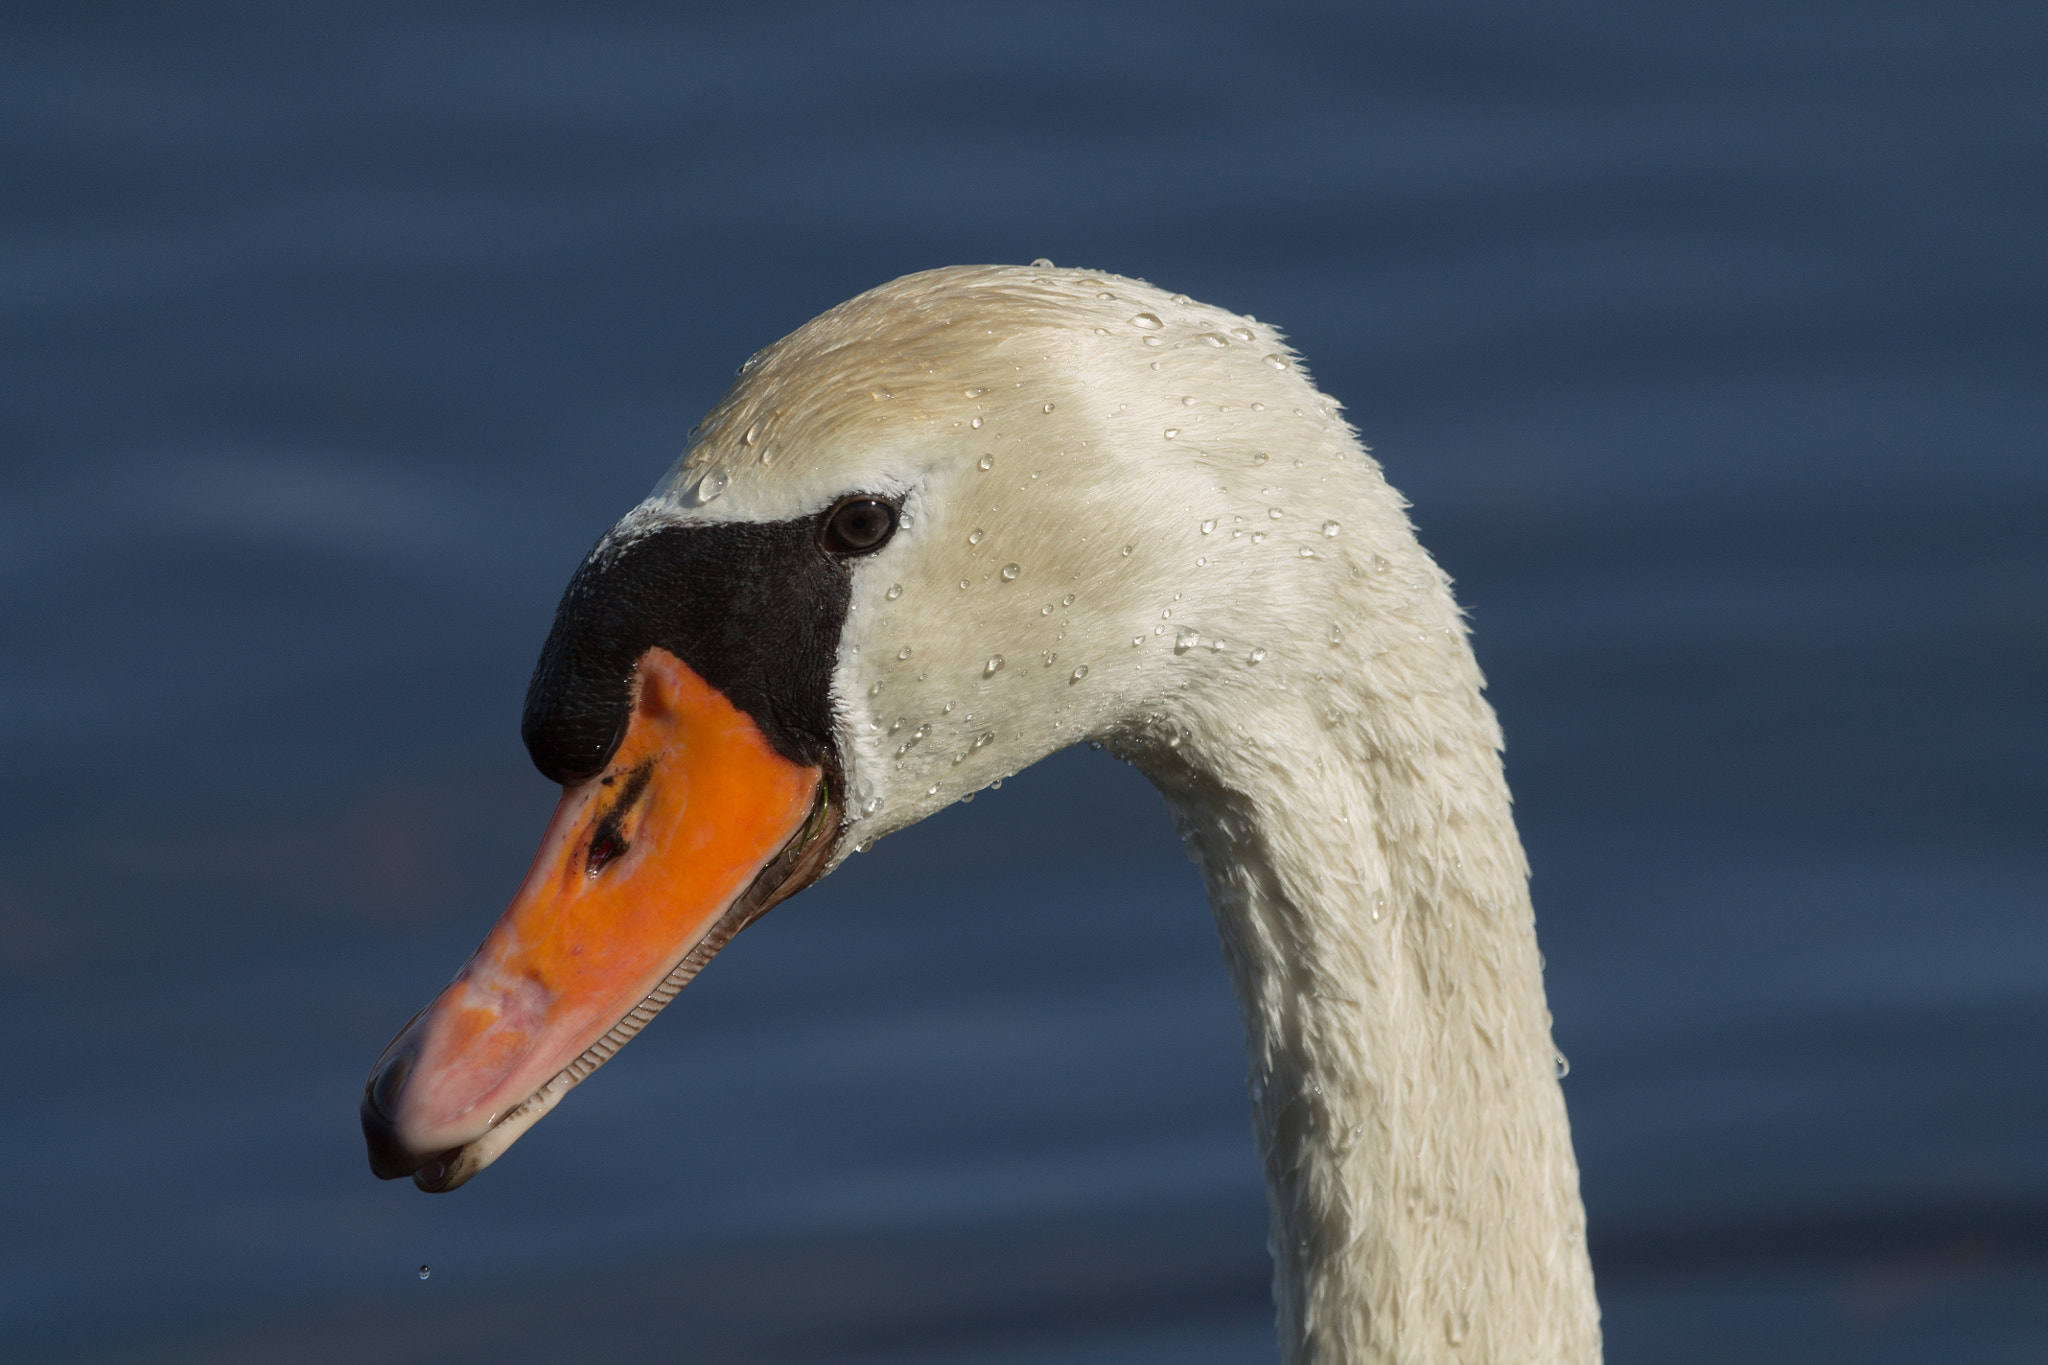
[1141,671,1599,1365]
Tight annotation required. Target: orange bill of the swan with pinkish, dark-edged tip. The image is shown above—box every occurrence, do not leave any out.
[362,649,836,1191]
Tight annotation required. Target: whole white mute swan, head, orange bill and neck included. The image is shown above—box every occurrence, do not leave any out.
[362,262,1599,1365]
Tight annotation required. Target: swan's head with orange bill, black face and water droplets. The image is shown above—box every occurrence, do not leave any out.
[362,266,1434,1191]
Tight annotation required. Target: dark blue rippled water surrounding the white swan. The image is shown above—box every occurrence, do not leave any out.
[0,4,2048,1365]
